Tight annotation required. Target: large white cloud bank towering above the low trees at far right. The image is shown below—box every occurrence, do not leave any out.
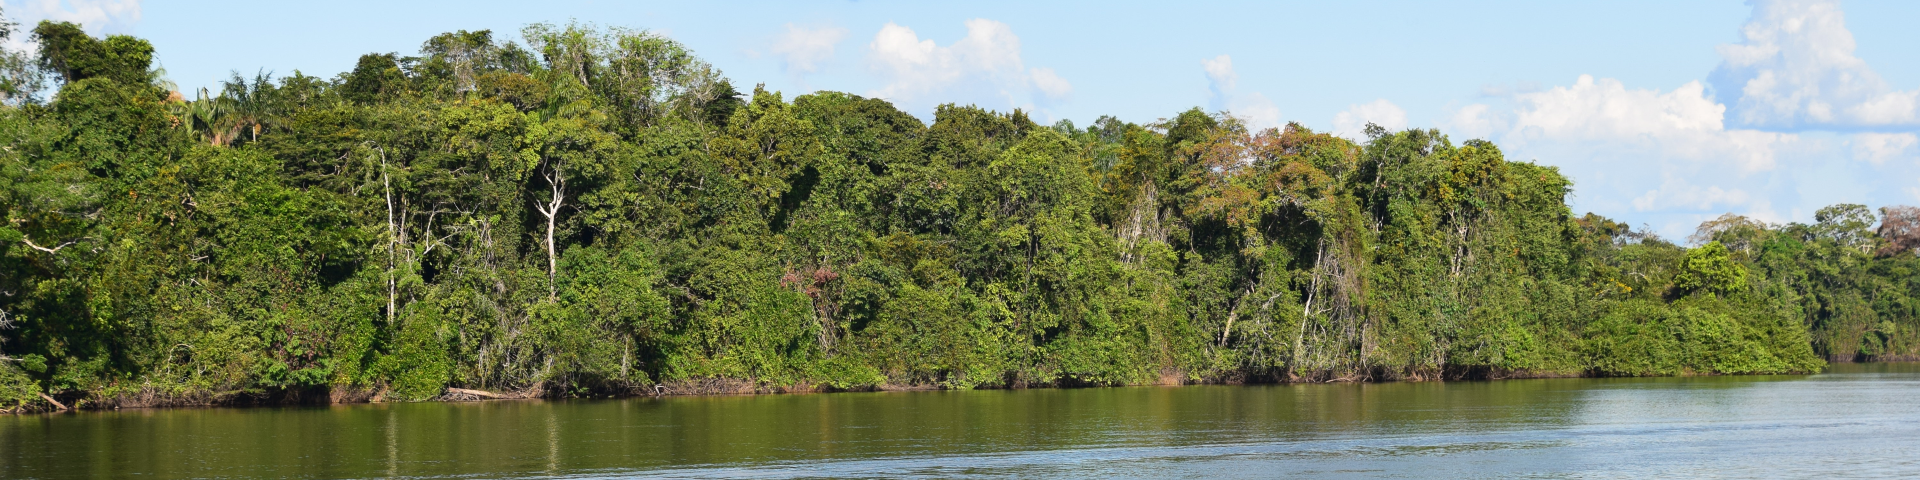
[1446,0,1920,238]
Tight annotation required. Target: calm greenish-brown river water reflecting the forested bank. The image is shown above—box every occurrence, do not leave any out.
[0,365,1920,478]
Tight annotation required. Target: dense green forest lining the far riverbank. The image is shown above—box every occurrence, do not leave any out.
[0,23,1920,411]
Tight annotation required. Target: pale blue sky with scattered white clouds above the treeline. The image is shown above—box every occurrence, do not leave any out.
[0,0,1920,240]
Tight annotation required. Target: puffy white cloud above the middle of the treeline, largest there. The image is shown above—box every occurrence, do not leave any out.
[868,19,1073,116]
